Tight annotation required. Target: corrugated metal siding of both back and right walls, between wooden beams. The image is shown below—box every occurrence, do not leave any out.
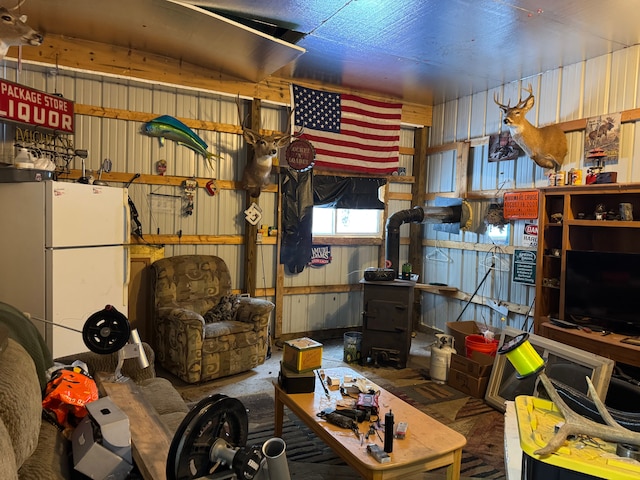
[6,43,640,340]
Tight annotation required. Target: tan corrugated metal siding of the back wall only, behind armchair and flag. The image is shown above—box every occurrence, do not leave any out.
[0,60,414,334]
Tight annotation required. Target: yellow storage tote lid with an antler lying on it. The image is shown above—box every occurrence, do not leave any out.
[515,395,640,480]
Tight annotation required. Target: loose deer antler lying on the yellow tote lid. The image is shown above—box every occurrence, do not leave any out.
[533,372,640,455]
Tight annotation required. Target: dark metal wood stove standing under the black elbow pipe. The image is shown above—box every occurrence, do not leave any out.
[360,279,416,368]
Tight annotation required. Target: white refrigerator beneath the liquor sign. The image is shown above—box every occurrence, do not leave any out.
[0,180,130,358]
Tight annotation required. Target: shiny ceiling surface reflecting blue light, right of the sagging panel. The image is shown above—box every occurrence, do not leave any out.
[188,0,640,104]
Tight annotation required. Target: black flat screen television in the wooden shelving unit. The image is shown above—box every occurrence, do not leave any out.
[564,250,640,336]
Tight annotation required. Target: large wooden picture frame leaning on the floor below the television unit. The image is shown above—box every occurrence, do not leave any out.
[485,327,615,412]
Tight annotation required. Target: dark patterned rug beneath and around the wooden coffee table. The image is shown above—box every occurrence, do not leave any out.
[239,390,506,480]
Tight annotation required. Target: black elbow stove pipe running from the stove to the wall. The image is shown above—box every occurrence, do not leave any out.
[385,202,471,278]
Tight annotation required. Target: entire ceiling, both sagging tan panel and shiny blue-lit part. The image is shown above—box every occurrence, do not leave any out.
[8,0,640,105]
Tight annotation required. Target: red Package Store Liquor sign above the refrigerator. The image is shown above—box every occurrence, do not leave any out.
[0,79,74,133]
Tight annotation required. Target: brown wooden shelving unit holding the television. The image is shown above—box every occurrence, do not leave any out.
[534,184,640,366]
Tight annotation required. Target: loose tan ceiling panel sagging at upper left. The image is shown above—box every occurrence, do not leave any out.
[20,0,304,82]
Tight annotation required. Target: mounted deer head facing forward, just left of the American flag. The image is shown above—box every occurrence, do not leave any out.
[236,100,293,197]
